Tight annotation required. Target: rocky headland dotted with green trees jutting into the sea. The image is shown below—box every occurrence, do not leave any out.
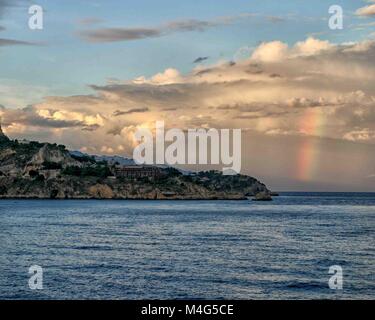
[0,139,269,199]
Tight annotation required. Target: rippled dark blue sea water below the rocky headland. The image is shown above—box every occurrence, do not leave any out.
[0,193,375,299]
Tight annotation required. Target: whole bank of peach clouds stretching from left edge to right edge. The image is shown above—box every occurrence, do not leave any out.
[4,38,375,158]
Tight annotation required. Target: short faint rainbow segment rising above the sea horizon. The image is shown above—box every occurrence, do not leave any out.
[296,108,324,181]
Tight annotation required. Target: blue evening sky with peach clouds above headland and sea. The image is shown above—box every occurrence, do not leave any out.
[0,0,375,191]
